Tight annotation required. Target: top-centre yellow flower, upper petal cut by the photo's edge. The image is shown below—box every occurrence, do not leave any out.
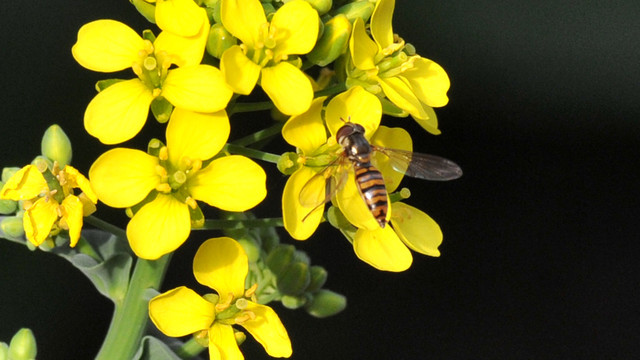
[220,0,319,115]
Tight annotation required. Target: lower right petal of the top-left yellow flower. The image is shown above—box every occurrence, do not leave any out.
[162,65,233,112]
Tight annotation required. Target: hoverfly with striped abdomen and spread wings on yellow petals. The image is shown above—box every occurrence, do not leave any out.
[300,119,462,228]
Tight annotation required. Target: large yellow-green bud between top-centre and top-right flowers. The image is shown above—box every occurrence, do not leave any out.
[307,14,351,66]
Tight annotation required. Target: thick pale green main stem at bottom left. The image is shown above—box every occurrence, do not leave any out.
[96,254,171,360]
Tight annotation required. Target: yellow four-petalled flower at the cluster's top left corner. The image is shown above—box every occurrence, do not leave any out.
[72,4,233,144]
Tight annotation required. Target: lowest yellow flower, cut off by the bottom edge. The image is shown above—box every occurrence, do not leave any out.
[149,237,292,360]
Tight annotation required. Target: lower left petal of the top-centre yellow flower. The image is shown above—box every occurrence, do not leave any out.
[220,45,262,95]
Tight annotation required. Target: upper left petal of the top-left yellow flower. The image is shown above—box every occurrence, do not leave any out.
[71,20,145,72]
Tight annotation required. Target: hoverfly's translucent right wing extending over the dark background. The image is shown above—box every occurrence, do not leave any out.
[373,146,462,181]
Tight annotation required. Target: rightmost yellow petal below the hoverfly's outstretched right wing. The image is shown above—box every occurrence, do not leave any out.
[391,202,442,256]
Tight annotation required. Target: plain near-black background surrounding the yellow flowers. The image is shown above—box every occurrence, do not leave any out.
[0,0,640,359]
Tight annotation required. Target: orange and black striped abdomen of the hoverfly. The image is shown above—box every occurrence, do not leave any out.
[353,162,389,228]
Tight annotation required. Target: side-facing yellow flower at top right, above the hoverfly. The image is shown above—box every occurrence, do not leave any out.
[347,0,450,134]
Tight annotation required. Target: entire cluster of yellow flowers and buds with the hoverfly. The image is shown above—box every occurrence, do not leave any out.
[0,0,461,359]
